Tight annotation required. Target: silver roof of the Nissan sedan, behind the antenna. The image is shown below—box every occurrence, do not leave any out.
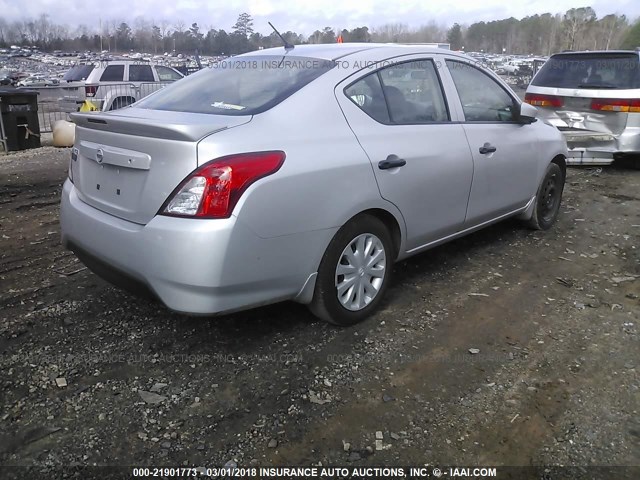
[243,43,458,60]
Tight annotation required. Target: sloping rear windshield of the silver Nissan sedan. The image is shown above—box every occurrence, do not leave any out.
[136,55,335,115]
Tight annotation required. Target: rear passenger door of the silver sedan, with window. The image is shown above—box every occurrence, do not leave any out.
[335,58,473,251]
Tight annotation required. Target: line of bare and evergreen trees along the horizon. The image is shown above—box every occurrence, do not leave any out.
[0,7,640,55]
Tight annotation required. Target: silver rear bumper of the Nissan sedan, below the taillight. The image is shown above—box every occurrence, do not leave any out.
[60,181,333,314]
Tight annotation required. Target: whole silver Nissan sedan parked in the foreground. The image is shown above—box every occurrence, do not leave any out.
[61,44,566,325]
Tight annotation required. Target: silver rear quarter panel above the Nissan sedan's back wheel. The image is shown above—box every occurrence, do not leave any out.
[198,72,403,242]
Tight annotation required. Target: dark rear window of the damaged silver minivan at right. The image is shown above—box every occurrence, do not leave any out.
[531,53,640,89]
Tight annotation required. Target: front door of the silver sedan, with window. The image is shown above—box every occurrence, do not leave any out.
[445,59,539,227]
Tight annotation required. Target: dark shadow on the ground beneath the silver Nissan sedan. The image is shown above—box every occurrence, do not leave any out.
[96,216,536,350]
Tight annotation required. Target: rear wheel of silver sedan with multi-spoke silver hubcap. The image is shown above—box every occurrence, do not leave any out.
[309,215,395,326]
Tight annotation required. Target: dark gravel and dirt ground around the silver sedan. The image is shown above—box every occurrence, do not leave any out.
[0,147,640,478]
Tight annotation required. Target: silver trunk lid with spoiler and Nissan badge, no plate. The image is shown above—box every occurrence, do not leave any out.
[71,108,251,225]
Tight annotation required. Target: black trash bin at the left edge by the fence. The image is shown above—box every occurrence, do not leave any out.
[0,88,40,151]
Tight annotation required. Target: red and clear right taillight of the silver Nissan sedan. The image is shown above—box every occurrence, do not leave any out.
[159,151,285,218]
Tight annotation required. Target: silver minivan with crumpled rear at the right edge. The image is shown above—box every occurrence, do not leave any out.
[525,51,640,168]
